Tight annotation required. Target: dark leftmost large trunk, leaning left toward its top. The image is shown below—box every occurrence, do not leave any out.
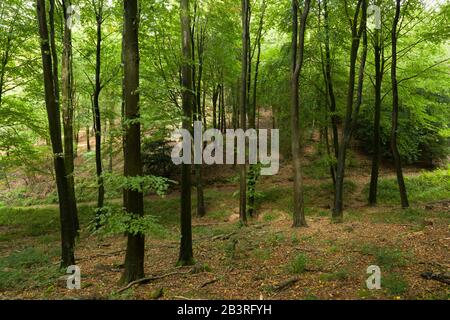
[36,0,76,267]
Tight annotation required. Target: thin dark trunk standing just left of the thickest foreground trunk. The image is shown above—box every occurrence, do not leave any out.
[93,0,105,218]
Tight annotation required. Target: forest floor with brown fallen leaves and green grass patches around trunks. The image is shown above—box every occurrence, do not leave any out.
[0,136,450,299]
